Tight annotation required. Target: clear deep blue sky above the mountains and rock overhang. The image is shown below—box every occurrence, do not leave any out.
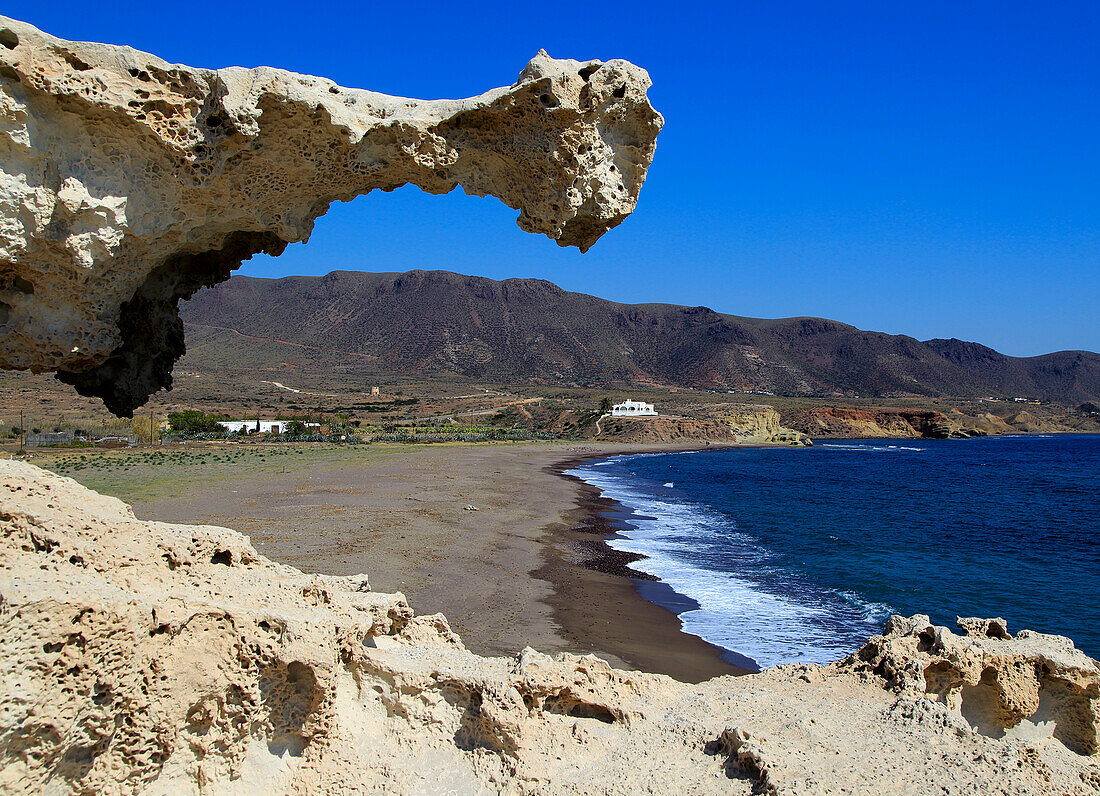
[10,0,1100,355]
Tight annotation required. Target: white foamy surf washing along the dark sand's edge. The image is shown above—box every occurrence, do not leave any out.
[570,454,889,667]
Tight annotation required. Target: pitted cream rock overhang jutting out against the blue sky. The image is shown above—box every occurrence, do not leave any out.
[0,16,663,416]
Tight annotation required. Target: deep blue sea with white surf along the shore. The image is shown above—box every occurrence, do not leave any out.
[570,434,1100,667]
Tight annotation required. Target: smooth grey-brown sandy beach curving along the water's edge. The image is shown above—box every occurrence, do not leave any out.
[122,443,743,682]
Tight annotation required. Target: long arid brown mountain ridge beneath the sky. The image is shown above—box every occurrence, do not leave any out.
[182,270,1100,405]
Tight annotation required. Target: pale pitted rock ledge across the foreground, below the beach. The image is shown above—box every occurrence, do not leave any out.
[0,461,1100,794]
